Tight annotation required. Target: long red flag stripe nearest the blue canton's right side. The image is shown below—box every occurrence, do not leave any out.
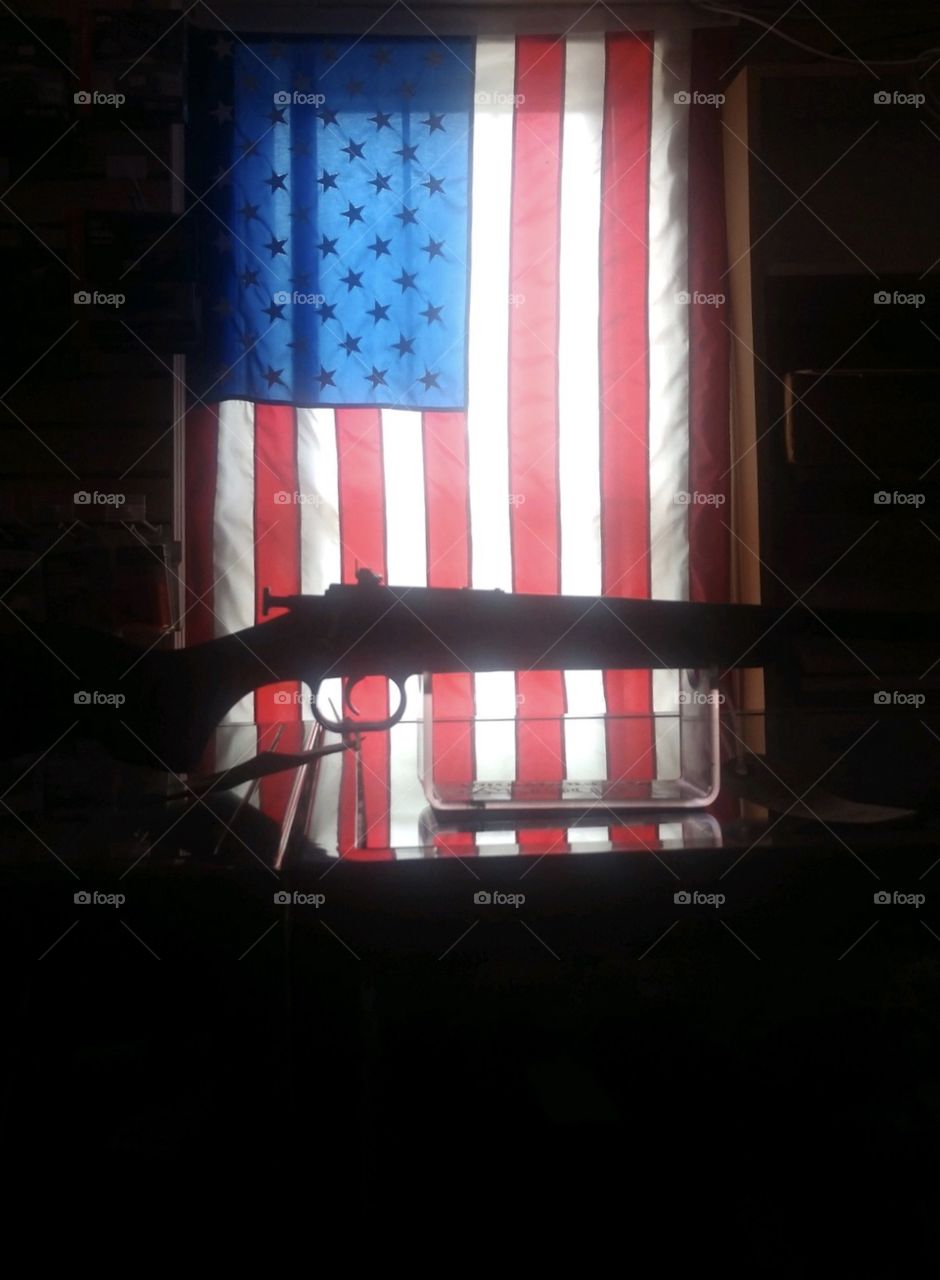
[508,37,565,849]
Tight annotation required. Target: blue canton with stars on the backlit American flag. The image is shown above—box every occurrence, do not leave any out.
[190,36,474,410]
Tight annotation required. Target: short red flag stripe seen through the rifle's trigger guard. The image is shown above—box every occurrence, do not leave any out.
[336,408,391,855]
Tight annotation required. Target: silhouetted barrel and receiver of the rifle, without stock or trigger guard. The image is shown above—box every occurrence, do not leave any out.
[294,585,940,675]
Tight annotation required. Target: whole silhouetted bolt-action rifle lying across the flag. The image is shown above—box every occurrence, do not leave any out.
[9,570,940,772]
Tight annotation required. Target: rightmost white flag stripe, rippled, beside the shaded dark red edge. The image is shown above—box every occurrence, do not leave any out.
[648,29,689,778]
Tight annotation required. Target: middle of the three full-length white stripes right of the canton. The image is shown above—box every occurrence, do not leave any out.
[558,35,607,778]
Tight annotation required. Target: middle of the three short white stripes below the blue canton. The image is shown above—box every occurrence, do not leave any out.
[297,408,344,854]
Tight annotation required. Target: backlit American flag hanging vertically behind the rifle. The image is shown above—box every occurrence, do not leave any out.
[186,31,729,852]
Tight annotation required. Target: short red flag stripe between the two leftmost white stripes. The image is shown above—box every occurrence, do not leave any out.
[255,404,301,822]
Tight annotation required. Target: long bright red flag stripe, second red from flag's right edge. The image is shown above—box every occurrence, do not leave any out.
[599,33,656,778]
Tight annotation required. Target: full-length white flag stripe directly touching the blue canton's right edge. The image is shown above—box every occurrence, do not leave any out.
[467,37,516,781]
